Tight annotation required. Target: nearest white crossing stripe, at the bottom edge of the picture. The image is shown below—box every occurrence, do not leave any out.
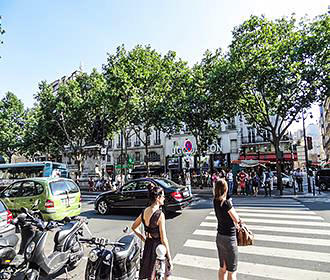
[173,254,330,280]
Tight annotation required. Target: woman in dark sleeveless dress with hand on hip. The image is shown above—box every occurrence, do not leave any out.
[132,184,172,280]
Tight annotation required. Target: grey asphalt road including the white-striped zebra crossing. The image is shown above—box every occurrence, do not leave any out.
[12,192,330,280]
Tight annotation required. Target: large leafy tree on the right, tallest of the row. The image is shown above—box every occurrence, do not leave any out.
[215,15,329,194]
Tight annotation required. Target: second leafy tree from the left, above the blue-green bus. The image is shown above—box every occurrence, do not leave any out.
[35,69,107,174]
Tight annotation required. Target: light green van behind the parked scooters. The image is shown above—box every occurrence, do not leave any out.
[0,177,81,220]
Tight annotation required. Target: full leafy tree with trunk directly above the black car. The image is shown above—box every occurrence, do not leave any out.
[103,45,187,176]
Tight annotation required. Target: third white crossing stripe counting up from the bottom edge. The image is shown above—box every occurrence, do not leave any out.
[193,229,330,246]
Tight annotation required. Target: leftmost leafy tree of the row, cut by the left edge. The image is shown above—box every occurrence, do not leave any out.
[0,92,26,162]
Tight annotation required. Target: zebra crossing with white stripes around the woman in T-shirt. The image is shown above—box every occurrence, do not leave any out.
[171,198,330,280]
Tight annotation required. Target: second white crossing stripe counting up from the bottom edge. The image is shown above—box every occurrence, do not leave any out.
[183,239,330,263]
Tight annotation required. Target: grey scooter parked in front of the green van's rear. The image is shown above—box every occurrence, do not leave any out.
[22,208,87,280]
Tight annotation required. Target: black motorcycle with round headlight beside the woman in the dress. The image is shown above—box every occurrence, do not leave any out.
[80,228,141,280]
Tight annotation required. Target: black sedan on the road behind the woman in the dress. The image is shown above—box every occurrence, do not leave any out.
[94,178,192,215]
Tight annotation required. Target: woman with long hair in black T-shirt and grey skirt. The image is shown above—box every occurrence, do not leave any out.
[213,179,241,280]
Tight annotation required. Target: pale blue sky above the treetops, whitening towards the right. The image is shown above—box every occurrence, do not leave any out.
[0,0,328,128]
